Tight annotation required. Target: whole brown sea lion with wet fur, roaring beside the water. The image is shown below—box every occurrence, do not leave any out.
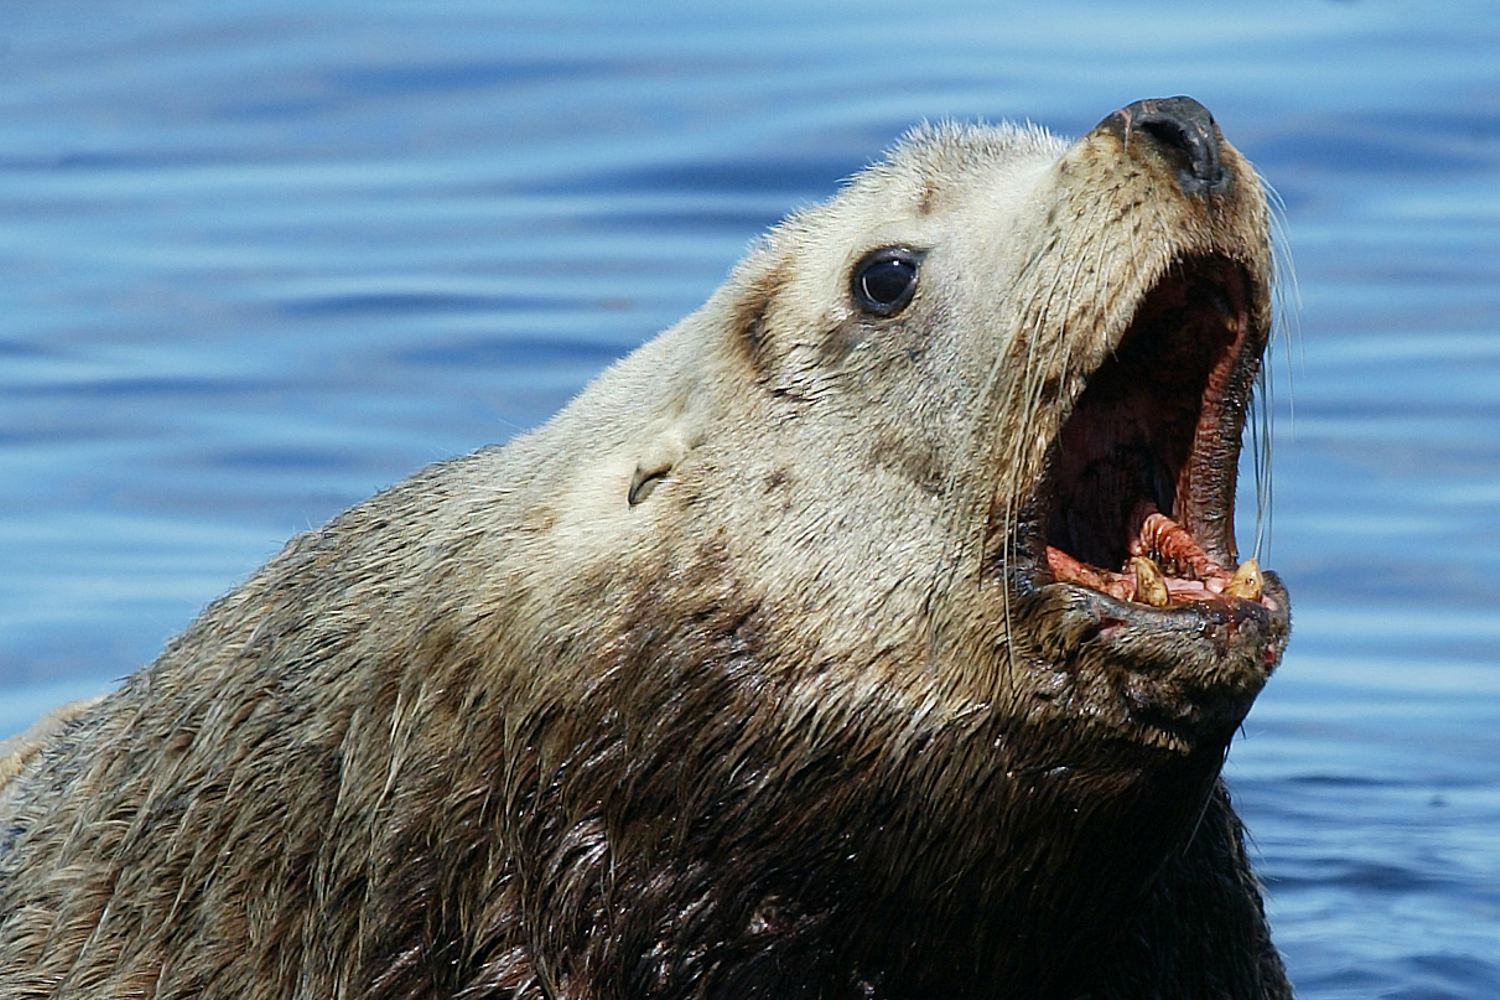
[0,97,1290,999]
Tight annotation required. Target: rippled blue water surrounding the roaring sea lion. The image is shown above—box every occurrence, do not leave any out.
[0,0,1500,1000]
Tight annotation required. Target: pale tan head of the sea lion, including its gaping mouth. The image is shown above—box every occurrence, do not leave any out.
[555,97,1289,766]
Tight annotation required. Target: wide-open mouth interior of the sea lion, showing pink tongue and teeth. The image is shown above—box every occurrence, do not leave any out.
[1026,256,1277,609]
